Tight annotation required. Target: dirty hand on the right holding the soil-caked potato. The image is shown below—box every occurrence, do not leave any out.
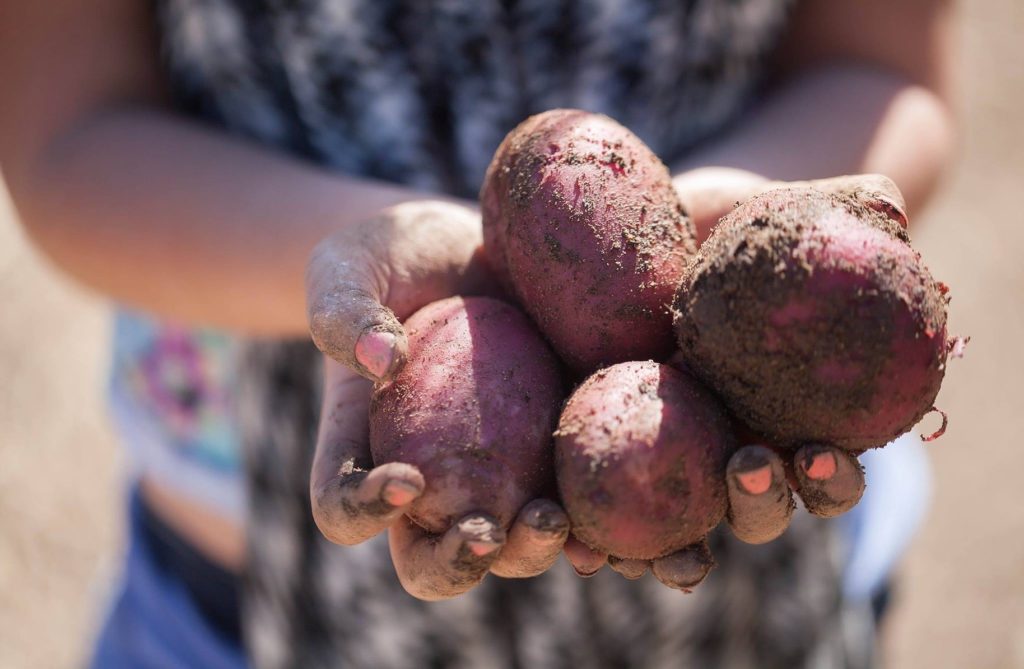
[674,168,907,544]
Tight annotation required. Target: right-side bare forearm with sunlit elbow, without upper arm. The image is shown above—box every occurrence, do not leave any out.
[676,65,954,213]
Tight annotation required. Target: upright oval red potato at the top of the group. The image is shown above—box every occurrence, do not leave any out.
[480,110,696,374]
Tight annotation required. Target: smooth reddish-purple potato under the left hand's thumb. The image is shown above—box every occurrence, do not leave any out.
[370,297,564,534]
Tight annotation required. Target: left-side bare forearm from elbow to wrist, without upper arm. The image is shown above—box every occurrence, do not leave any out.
[11,111,460,335]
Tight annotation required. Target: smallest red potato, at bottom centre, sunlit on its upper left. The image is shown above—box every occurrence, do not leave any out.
[555,362,735,559]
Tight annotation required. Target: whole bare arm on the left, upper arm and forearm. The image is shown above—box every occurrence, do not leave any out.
[0,0,450,335]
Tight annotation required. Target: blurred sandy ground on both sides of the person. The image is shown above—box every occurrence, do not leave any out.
[0,0,1024,669]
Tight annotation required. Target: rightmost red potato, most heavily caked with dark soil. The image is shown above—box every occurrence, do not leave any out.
[675,189,948,451]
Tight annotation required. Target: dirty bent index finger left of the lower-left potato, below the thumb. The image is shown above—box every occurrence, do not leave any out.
[309,360,425,545]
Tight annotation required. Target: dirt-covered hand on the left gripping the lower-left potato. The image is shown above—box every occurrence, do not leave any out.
[306,201,569,600]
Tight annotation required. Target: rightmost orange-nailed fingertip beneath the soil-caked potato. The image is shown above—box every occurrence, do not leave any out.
[794,444,864,517]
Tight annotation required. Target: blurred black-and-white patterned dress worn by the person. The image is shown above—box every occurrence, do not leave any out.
[142,0,871,669]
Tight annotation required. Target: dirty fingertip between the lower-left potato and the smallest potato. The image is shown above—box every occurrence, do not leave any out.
[490,499,569,579]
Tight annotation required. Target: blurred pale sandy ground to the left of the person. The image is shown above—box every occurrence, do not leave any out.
[0,193,120,667]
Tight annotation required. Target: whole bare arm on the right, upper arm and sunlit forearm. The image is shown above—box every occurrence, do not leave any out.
[677,0,954,214]
